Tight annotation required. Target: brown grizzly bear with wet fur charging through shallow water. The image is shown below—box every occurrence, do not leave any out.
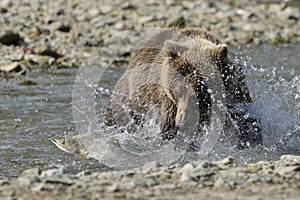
[104,28,262,148]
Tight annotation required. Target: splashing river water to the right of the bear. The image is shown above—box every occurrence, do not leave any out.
[238,45,300,158]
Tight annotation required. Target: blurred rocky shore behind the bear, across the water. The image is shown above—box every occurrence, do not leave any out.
[0,0,300,79]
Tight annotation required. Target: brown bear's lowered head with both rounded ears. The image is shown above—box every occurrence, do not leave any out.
[163,37,228,86]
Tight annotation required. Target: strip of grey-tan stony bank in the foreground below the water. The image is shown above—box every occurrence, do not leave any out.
[0,155,300,200]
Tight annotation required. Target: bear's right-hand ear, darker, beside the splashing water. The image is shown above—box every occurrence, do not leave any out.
[209,44,228,66]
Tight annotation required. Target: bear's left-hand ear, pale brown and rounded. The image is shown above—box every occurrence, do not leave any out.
[163,40,186,60]
